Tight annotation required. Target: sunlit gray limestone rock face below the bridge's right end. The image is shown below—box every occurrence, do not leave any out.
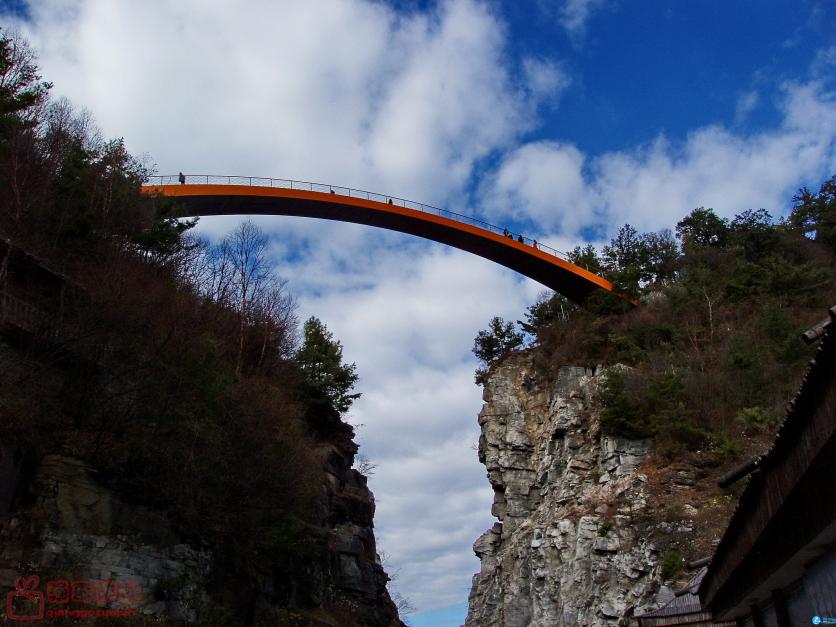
[466,353,660,627]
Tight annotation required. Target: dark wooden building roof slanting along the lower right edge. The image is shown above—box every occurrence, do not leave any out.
[699,307,836,620]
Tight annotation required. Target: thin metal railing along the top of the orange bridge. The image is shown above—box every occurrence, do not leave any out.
[146,174,592,272]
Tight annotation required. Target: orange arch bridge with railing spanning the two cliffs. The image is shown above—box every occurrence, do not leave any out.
[142,175,613,302]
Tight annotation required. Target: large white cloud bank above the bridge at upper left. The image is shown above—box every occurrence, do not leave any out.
[11,0,548,202]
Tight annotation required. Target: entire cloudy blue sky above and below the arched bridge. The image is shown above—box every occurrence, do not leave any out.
[0,0,836,625]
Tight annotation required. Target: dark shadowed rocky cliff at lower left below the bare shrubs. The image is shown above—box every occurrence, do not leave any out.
[0,341,402,627]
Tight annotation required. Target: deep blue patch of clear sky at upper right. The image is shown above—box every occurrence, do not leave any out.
[507,0,836,153]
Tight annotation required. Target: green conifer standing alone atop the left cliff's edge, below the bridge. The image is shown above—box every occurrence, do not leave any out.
[296,317,360,413]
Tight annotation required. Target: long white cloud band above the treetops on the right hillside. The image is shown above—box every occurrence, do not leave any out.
[482,82,836,238]
